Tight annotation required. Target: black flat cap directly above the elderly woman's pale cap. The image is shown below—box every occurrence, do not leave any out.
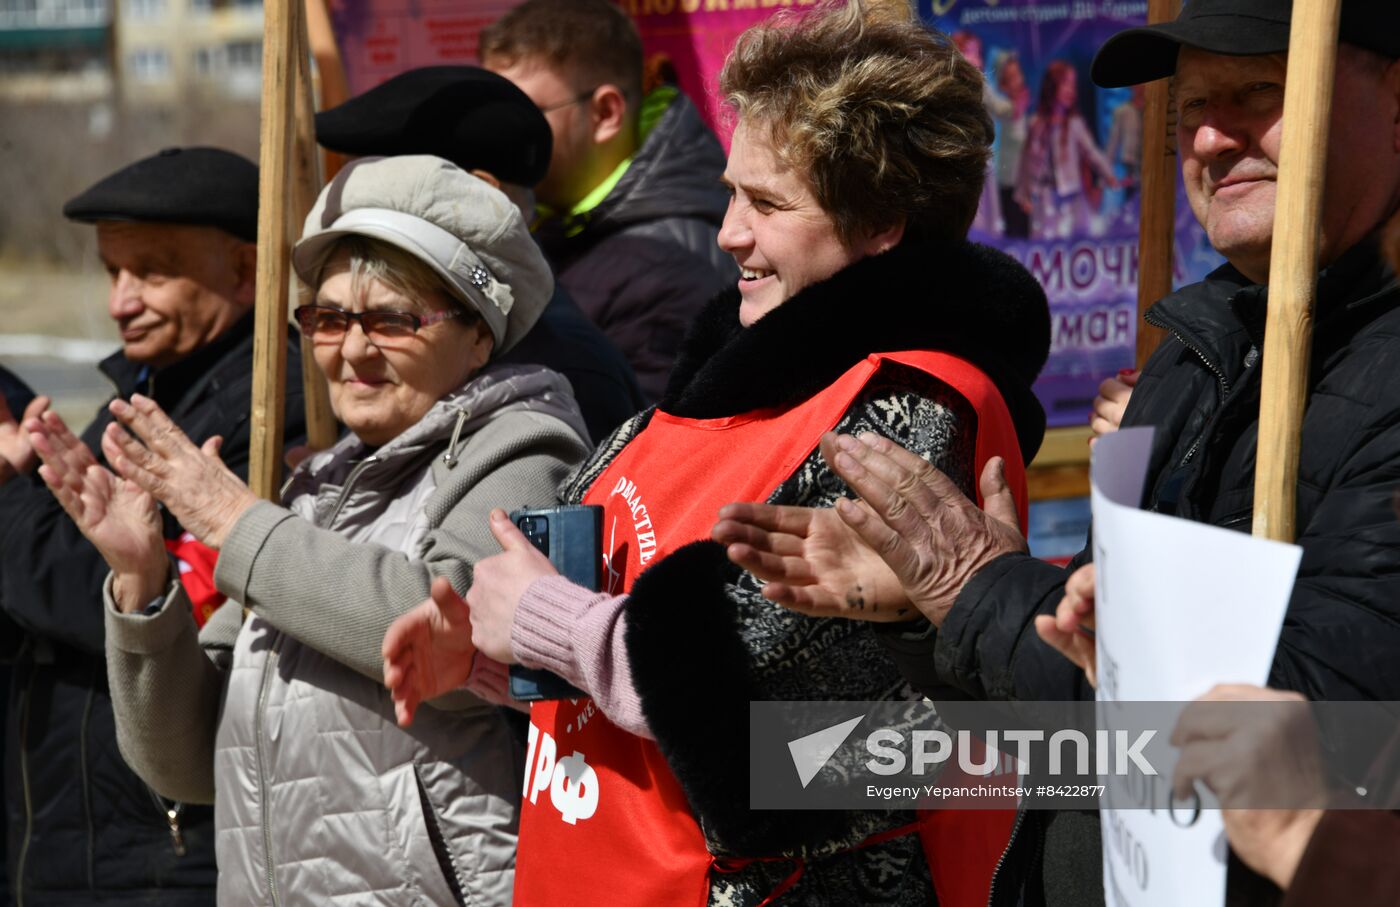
[316,66,553,188]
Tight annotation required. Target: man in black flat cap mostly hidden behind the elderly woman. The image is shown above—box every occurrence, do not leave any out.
[316,66,645,441]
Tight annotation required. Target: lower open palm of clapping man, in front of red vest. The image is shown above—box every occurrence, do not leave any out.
[710,495,917,620]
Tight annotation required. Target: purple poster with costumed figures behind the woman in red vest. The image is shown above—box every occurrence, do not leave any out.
[918,0,1221,426]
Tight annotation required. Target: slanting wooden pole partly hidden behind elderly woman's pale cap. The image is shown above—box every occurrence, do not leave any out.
[287,0,339,451]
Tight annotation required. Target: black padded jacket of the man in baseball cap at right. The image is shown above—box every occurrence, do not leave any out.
[885,242,1400,906]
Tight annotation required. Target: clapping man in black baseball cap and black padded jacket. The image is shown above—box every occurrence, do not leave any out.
[862,0,1400,688]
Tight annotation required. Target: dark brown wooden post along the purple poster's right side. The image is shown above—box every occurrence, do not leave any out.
[1135,0,1182,368]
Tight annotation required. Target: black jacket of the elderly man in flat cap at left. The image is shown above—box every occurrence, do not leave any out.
[0,316,305,907]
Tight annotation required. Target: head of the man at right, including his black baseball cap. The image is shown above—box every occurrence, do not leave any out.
[1092,0,1400,284]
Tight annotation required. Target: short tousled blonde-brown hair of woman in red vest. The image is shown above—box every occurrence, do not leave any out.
[720,0,994,242]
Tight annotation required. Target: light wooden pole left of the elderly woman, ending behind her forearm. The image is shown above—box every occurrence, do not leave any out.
[248,0,301,500]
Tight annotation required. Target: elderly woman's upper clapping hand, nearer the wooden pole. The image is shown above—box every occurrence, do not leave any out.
[102,393,258,550]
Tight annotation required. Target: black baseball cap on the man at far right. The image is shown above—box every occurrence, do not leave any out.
[1089,0,1400,88]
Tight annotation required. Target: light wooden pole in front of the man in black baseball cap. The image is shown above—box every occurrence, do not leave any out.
[1254,0,1341,542]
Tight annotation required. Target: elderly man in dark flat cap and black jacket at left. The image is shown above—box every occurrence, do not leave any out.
[0,148,305,907]
